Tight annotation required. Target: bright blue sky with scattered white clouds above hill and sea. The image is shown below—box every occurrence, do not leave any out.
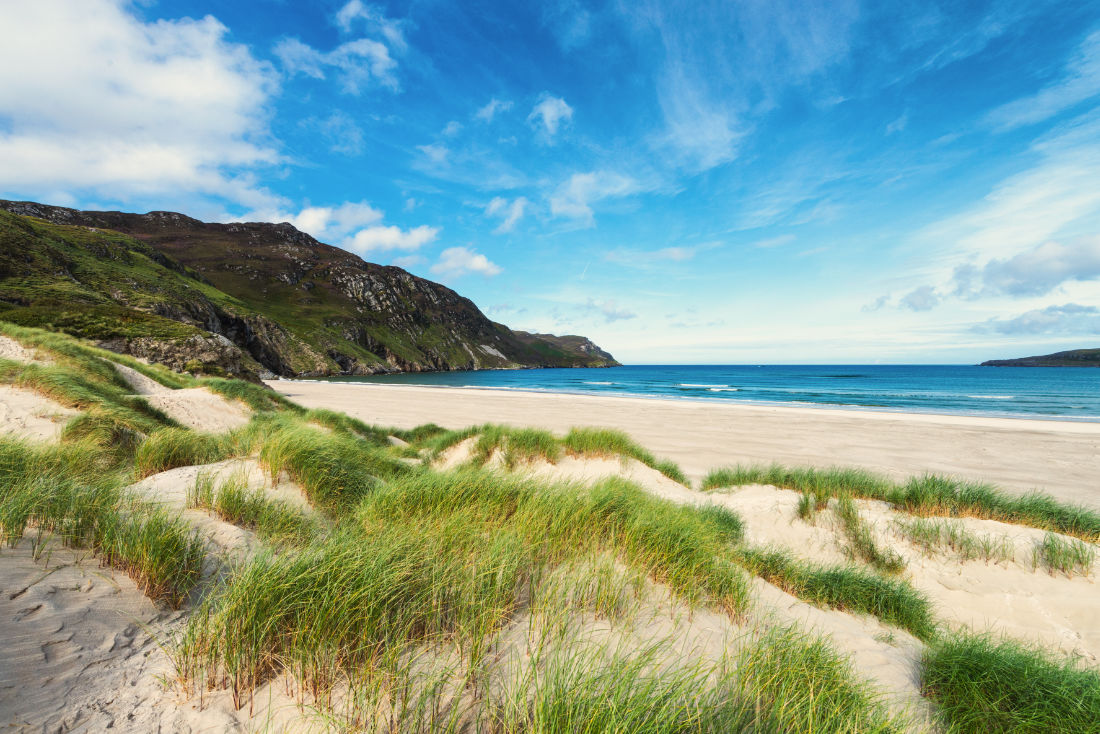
[0,0,1100,363]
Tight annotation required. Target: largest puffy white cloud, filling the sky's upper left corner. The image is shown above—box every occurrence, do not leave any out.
[0,0,279,207]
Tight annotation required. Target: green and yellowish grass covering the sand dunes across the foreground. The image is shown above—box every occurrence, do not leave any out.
[0,325,1100,734]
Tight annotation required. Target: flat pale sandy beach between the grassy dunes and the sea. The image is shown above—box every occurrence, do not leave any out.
[267,380,1100,507]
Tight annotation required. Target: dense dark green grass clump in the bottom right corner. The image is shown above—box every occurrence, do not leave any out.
[922,633,1100,734]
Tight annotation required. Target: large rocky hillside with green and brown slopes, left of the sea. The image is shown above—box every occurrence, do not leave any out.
[0,201,616,376]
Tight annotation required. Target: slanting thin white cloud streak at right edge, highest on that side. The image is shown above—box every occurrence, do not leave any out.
[987,31,1100,130]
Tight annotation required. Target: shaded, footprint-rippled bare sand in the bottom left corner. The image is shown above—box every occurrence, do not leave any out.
[0,538,322,734]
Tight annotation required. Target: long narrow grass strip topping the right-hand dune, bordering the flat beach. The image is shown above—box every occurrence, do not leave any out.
[703,464,1100,543]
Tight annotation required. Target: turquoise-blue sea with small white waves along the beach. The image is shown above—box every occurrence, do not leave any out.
[323,364,1100,420]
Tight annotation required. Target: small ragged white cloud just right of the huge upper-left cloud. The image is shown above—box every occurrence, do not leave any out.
[274,39,399,95]
